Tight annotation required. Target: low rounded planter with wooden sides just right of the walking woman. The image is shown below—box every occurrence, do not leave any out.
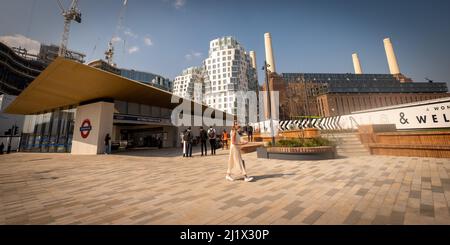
[256,146,336,160]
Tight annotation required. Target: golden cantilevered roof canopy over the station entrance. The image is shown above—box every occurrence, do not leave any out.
[4,58,232,118]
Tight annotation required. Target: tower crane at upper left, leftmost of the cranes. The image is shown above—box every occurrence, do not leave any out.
[57,0,81,57]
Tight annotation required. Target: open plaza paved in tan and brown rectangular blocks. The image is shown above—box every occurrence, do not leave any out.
[0,149,450,224]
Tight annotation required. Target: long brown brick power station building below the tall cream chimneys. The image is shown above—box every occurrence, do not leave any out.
[263,73,450,120]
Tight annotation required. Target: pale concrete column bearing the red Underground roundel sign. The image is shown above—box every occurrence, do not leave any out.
[71,102,114,155]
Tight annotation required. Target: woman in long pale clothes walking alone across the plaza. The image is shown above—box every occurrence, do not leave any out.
[225,121,253,182]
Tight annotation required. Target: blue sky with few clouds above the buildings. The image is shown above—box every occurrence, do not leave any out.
[0,0,450,85]
